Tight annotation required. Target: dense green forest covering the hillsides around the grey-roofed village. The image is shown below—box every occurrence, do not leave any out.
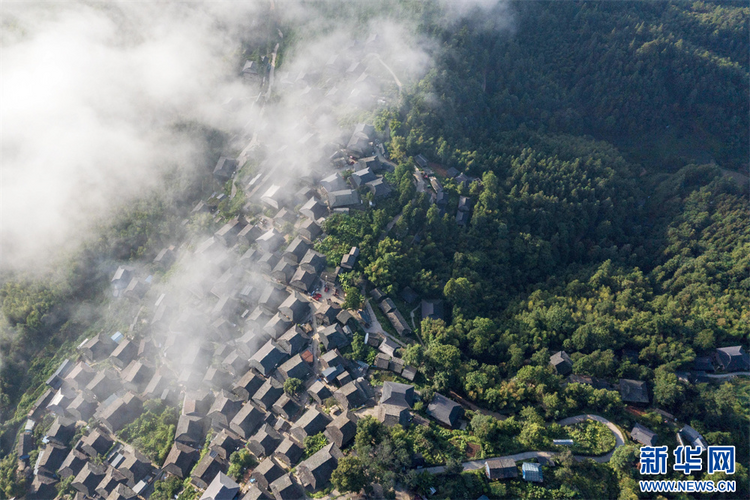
[0,0,750,498]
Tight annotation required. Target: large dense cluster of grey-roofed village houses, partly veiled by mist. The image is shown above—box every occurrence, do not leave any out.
[17,111,478,500]
